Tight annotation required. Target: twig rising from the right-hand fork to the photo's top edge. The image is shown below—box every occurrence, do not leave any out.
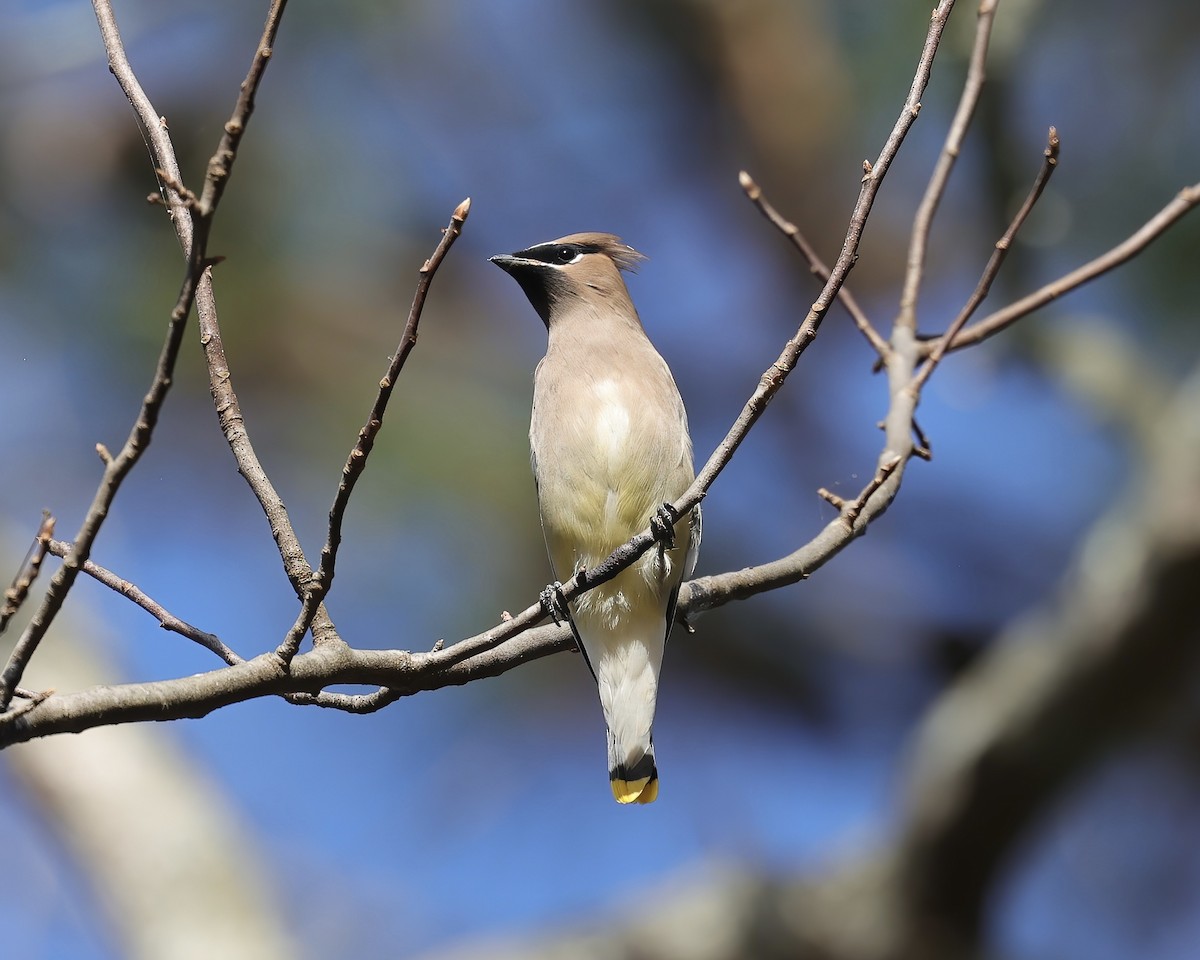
[895,0,996,334]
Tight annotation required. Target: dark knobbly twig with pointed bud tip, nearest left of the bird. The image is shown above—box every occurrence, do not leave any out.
[276,197,470,662]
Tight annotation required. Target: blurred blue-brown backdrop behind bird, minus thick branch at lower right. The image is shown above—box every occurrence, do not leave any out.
[0,0,1200,960]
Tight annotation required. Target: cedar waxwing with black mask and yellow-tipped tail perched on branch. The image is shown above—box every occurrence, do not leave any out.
[491,233,700,803]
